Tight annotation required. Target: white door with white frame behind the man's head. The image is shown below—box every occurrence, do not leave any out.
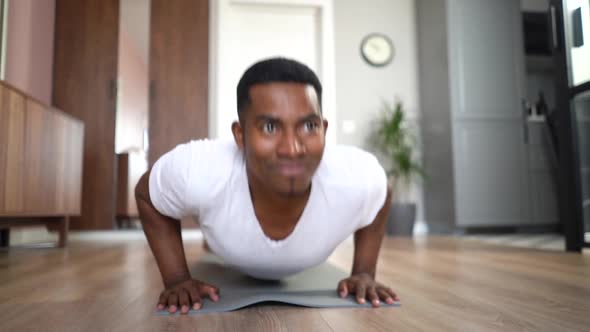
[209,0,336,139]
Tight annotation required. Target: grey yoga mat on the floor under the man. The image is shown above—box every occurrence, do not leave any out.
[156,255,400,316]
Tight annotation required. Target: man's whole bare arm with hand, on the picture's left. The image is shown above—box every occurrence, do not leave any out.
[135,170,218,312]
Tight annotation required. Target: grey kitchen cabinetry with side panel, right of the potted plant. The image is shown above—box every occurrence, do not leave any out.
[416,0,557,233]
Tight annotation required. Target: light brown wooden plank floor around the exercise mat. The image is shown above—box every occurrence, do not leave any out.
[0,235,590,331]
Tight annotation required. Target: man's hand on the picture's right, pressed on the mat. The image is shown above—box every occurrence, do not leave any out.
[338,273,399,307]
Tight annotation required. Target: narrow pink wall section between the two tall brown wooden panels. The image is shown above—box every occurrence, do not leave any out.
[115,28,148,152]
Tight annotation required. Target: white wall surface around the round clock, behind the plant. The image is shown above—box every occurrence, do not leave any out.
[328,0,423,231]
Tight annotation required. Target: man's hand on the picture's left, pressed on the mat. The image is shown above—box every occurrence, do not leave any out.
[157,279,219,314]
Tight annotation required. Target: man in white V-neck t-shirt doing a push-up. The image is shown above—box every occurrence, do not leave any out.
[136,58,399,313]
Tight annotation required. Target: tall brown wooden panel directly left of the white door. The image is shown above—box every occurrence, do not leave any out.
[148,0,210,165]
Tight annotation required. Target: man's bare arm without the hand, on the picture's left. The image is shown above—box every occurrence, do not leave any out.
[136,173,191,287]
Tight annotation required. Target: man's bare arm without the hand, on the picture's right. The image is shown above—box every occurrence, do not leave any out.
[352,188,391,278]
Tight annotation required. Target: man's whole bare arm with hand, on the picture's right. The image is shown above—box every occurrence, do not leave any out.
[338,185,399,307]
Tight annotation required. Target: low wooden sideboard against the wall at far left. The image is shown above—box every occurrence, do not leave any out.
[0,82,84,244]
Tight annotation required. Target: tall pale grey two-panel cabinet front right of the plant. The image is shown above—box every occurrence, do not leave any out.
[448,0,531,226]
